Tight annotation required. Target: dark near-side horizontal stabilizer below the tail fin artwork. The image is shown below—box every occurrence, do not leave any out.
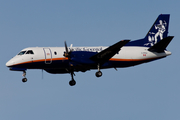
[148,36,174,53]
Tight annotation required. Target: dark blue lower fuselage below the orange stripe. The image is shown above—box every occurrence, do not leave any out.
[8,57,163,71]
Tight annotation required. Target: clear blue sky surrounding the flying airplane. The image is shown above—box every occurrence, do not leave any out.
[0,0,180,120]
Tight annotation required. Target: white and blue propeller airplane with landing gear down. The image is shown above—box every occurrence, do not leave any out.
[6,14,174,86]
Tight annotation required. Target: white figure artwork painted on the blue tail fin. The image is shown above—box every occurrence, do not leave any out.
[144,20,167,46]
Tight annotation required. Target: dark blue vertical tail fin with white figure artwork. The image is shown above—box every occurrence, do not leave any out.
[126,14,170,47]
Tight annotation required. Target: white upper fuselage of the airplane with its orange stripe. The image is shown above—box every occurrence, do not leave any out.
[6,46,171,69]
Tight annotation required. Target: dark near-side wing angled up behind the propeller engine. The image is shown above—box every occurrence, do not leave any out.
[90,40,130,63]
